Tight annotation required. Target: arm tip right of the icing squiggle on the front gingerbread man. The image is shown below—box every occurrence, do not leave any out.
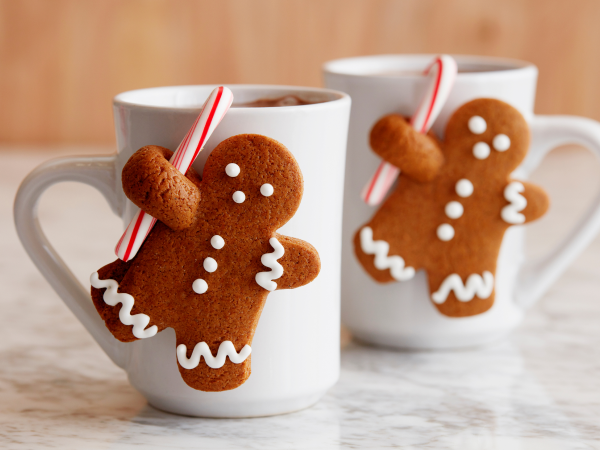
[274,234,321,289]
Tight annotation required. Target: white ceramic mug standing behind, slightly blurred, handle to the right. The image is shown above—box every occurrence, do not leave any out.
[323,55,600,349]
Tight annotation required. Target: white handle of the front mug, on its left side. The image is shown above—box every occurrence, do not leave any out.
[13,154,128,368]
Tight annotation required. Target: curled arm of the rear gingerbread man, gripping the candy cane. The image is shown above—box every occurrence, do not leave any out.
[369,114,444,181]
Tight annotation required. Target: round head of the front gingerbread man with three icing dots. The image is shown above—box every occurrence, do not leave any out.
[202,134,303,232]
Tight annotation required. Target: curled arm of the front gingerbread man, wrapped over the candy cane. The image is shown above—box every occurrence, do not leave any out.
[122,145,200,230]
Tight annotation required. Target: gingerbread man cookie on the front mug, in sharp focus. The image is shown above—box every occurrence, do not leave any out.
[92,134,320,391]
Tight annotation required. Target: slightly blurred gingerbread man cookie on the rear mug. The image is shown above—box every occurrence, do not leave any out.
[354,99,549,317]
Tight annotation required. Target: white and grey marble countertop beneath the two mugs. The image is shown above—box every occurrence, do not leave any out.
[0,148,600,450]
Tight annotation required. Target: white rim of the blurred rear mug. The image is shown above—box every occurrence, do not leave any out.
[322,53,538,80]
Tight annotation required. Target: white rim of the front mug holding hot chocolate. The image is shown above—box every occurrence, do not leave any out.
[113,84,350,114]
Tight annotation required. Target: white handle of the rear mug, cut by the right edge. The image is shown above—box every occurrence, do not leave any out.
[515,116,600,308]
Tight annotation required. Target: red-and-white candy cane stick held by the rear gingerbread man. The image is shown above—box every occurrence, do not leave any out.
[361,55,457,206]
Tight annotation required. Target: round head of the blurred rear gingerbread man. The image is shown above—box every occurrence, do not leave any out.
[446,98,529,175]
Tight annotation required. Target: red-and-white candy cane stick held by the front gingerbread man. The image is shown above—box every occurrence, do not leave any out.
[115,86,233,262]
